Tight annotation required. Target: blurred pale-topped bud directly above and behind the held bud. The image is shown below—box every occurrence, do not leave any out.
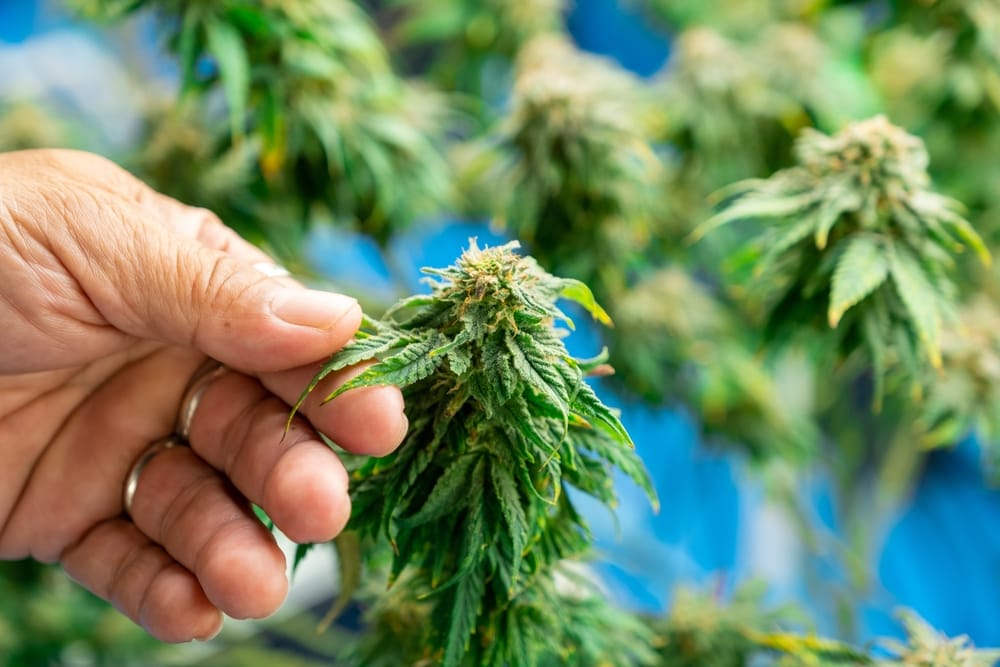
[462,36,662,295]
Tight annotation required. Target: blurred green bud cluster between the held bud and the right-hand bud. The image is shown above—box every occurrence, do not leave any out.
[611,266,819,464]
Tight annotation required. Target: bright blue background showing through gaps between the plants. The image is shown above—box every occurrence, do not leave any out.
[0,0,1000,646]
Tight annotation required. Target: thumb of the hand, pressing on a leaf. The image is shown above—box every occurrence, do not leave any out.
[57,200,361,372]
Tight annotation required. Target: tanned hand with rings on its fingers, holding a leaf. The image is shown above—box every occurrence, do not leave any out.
[0,150,406,642]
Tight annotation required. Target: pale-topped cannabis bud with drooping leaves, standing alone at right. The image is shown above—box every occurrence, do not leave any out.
[695,116,990,401]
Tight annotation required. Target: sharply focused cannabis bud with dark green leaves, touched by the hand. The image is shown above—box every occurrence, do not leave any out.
[294,242,654,665]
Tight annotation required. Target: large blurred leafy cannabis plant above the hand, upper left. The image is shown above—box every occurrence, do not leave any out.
[78,0,451,249]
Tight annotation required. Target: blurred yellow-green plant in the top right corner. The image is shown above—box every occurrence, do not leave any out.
[865,0,1000,240]
